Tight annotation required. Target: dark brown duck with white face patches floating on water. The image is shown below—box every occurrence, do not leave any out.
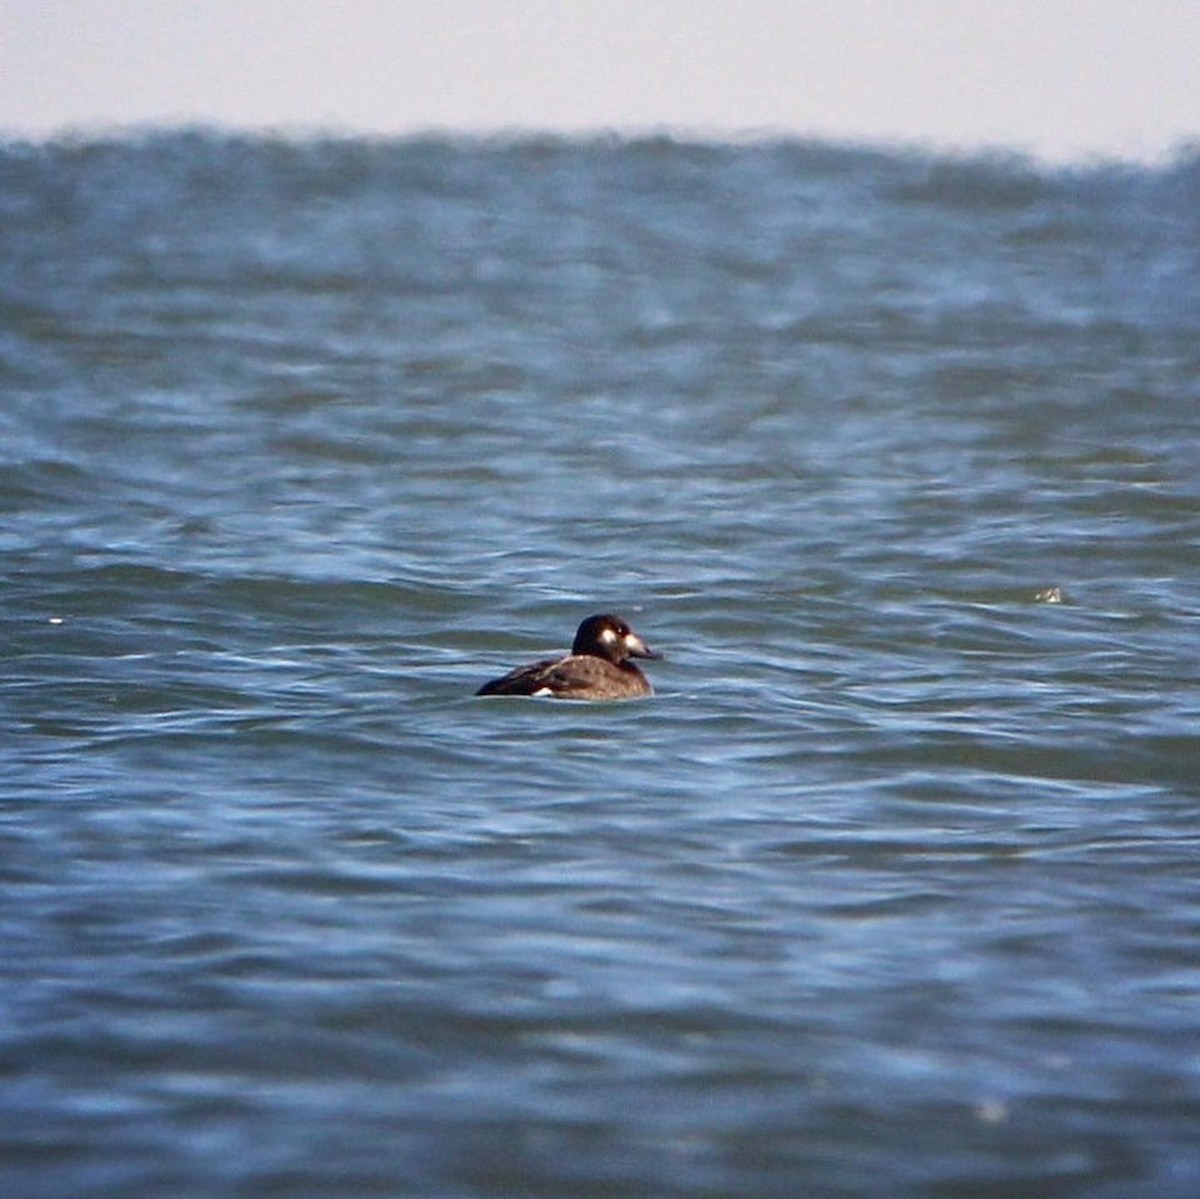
[475,613,662,700]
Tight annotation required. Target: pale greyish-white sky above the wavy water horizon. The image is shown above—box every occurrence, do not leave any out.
[0,0,1200,162]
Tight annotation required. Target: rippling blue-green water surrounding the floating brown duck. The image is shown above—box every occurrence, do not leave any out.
[0,132,1200,1199]
